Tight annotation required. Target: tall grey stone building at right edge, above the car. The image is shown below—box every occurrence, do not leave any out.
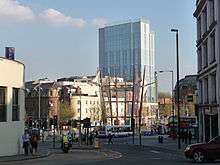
[194,0,220,141]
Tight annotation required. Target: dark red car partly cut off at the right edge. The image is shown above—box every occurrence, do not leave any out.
[184,136,220,163]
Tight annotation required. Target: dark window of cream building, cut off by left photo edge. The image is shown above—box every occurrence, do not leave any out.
[0,87,7,122]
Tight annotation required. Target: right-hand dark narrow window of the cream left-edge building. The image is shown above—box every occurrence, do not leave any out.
[12,88,20,121]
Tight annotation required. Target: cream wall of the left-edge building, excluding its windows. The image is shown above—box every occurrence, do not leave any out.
[0,58,25,156]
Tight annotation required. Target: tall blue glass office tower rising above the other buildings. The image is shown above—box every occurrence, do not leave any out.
[99,19,156,102]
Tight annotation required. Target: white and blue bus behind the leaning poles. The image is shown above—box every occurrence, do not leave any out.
[98,125,132,138]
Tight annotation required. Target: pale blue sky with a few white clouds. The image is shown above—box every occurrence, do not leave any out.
[0,0,197,92]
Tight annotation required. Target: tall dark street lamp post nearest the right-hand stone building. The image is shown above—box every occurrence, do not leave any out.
[171,29,181,149]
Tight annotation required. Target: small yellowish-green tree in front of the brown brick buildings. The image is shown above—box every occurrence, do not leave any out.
[59,101,75,121]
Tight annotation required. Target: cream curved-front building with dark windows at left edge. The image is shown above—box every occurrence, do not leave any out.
[0,57,25,156]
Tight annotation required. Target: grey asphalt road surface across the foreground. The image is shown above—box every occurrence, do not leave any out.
[1,137,220,165]
